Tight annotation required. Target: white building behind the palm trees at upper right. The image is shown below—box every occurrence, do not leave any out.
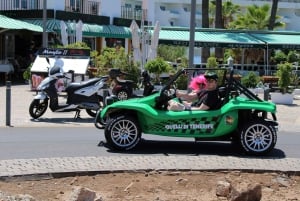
[118,0,300,31]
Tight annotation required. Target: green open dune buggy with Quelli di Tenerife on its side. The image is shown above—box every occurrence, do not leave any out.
[96,68,278,155]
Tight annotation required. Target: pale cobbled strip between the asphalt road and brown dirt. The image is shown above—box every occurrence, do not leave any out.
[0,156,300,178]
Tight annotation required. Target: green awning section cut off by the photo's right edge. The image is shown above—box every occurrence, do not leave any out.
[251,32,300,49]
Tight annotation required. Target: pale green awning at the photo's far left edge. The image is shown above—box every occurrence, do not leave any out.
[0,15,43,32]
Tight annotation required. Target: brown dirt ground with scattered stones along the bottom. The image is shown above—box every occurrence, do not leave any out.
[0,171,300,201]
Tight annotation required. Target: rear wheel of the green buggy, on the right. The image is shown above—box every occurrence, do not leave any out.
[240,120,277,156]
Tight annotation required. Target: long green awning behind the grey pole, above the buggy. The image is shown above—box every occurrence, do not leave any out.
[159,29,265,48]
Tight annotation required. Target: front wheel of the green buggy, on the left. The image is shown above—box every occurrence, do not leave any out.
[104,115,141,151]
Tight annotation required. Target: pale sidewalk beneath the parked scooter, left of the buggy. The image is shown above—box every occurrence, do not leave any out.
[0,84,94,127]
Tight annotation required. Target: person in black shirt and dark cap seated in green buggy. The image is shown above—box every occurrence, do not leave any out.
[168,72,220,111]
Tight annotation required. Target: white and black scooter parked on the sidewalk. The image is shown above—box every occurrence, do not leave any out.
[29,58,109,119]
